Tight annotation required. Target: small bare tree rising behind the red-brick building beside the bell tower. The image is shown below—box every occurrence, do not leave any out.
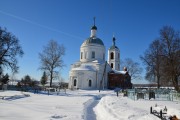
[121,58,142,80]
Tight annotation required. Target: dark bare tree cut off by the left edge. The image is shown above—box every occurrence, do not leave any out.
[0,27,24,74]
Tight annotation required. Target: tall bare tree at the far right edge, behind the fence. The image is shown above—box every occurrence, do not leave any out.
[160,26,180,91]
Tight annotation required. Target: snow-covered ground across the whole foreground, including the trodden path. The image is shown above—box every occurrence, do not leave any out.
[0,90,180,120]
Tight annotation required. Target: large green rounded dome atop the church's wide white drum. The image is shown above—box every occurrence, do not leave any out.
[82,37,104,46]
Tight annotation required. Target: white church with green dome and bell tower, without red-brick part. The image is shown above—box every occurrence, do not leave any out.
[68,21,124,89]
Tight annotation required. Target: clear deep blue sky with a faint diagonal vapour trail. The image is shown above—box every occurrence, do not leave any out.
[0,0,180,83]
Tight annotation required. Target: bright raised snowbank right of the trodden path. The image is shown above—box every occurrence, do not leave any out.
[94,96,180,120]
